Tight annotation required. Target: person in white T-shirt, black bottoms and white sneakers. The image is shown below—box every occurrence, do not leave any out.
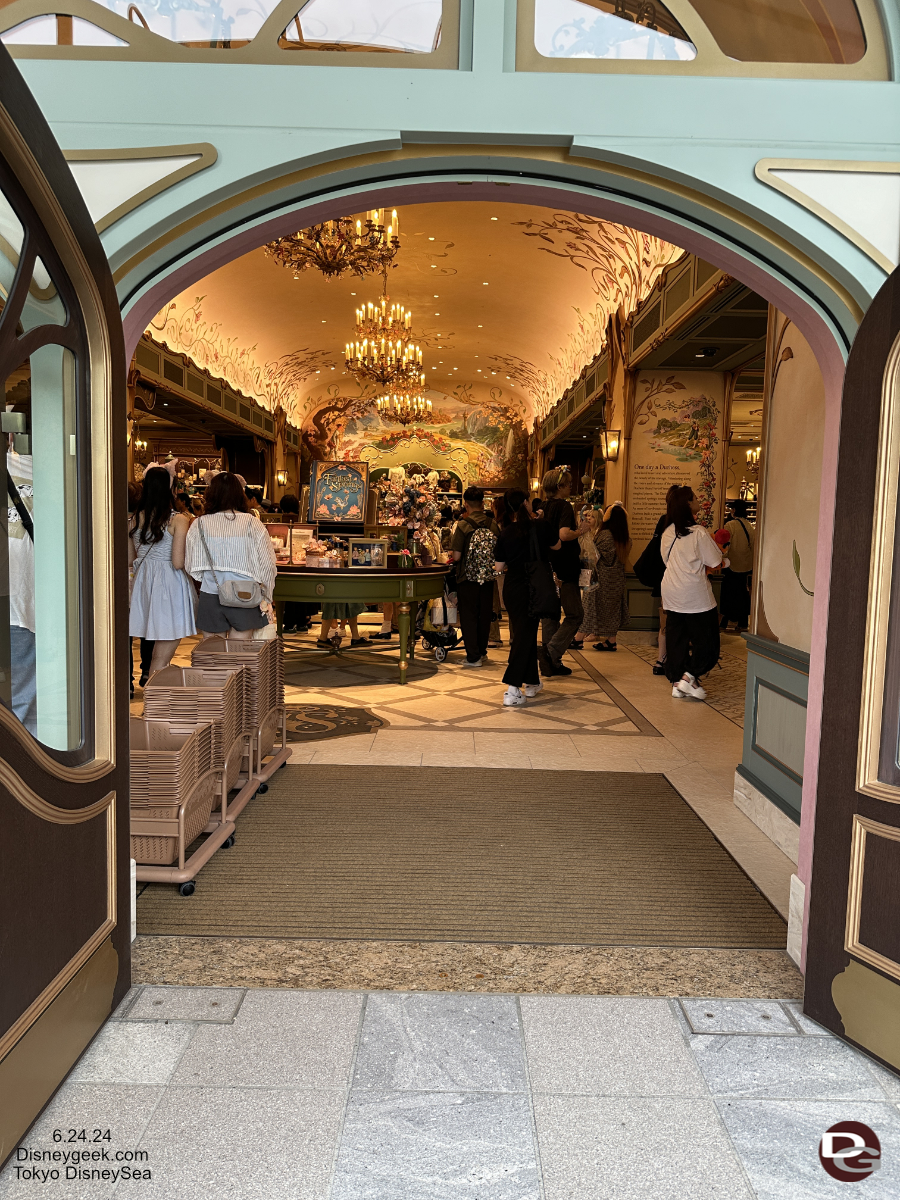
[660,487,728,700]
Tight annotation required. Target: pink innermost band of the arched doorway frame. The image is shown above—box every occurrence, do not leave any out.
[125,181,845,961]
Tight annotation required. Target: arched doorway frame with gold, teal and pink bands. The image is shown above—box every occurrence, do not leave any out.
[118,159,860,960]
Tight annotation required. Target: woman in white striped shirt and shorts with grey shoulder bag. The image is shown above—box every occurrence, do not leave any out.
[185,470,277,641]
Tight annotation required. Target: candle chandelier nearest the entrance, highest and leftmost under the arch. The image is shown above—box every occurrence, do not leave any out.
[265,209,400,280]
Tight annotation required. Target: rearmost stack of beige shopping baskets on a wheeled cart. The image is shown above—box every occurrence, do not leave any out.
[191,637,290,801]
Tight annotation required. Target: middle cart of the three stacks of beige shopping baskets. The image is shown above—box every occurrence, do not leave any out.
[144,664,258,833]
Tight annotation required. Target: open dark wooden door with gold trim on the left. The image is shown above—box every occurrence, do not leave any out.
[0,46,131,1163]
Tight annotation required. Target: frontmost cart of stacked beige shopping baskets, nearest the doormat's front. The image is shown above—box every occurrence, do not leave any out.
[131,716,234,896]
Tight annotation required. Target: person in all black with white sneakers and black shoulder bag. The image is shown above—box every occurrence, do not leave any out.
[494,491,559,707]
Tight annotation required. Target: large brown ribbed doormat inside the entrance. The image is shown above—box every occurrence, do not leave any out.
[138,764,786,949]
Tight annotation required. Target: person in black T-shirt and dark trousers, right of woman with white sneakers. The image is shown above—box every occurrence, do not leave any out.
[538,467,590,676]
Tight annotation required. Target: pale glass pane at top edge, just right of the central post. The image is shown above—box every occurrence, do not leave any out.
[534,0,697,61]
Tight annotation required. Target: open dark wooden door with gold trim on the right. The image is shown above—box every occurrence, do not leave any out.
[804,271,900,1072]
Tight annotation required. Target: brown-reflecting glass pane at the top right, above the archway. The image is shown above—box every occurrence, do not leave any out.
[691,0,865,62]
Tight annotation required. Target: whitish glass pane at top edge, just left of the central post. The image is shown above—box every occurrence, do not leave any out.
[280,0,442,54]
